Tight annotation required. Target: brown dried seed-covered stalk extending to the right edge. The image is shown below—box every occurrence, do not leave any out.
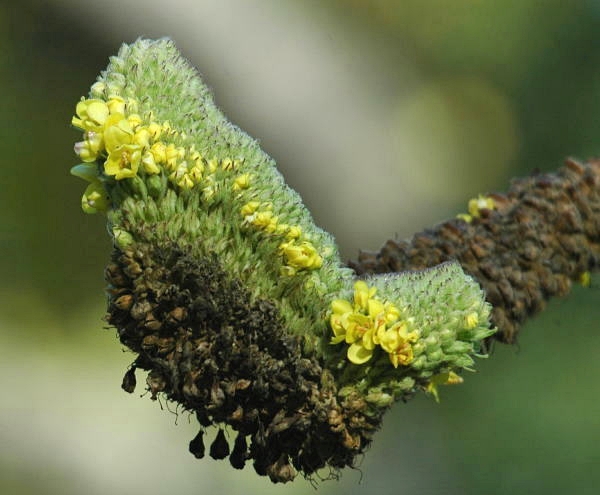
[350,159,600,343]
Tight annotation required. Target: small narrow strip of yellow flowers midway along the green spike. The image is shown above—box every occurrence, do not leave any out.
[240,201,323,276]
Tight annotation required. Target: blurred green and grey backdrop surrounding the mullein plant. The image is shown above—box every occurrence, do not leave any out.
[0,0,600,495]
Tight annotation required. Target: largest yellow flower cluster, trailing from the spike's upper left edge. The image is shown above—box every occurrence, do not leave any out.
[71,96,244,213]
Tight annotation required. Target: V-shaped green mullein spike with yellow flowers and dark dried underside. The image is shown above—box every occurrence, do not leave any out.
[72,39,494,482]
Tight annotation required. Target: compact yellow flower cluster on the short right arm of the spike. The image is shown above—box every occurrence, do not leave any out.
[329,280,420,368]
